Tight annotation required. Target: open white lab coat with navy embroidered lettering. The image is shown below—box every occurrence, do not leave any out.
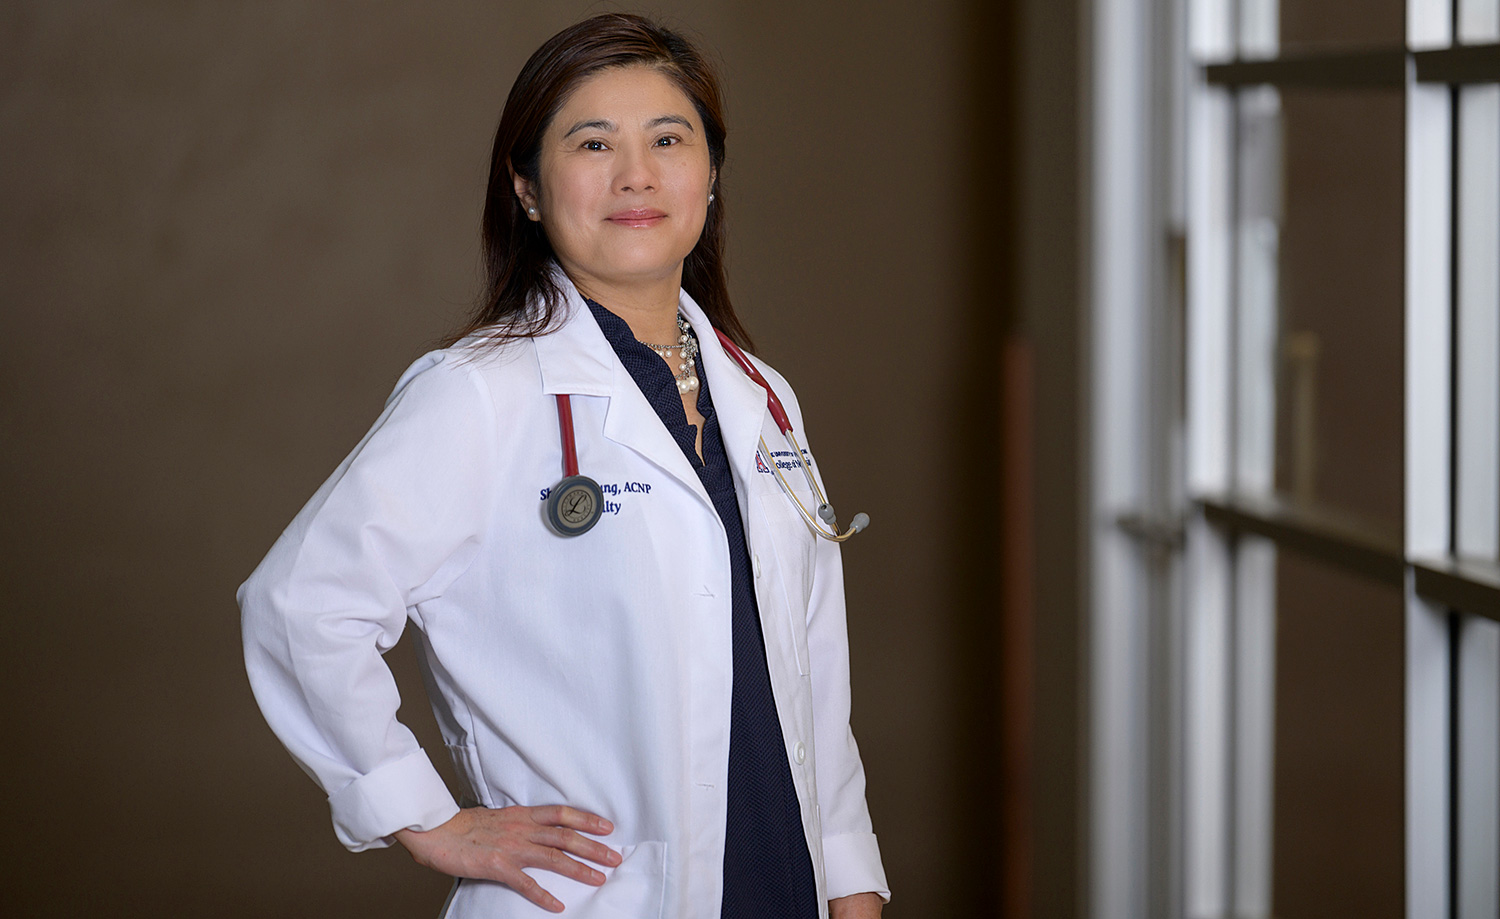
[240,278,888,919]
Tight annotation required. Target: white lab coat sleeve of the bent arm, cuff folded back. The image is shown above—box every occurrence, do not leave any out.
[239,355,497,852]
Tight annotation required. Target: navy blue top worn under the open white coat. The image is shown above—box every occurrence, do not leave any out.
[588,300,818,919]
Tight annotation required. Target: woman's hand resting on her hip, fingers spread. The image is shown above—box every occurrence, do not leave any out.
[396,805,620,913]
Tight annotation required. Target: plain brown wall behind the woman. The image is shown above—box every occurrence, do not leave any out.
[0,0,1073,919]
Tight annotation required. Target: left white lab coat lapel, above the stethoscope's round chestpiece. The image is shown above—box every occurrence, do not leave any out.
[533,283,714,508]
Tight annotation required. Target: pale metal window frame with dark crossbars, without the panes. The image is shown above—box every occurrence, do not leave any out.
[1091,0,1500,919]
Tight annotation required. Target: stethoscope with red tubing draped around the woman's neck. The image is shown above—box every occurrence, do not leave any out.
[546,328,870,543]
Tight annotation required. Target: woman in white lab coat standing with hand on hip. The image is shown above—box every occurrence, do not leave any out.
[240,13,888,919]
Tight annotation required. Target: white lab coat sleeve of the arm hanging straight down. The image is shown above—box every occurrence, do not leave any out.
[776,361,891,901]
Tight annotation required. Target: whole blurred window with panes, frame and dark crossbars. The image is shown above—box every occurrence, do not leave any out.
[1091,0,1500,919]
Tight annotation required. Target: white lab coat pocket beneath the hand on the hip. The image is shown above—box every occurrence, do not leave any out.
[443,843,666,919]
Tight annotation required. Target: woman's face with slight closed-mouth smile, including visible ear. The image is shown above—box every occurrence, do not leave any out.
[516,66,714,291]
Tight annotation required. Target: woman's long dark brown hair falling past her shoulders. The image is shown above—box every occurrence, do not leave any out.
[447,13,750,349]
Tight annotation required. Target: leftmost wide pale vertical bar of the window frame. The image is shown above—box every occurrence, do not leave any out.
[1089,0,1152,919]
